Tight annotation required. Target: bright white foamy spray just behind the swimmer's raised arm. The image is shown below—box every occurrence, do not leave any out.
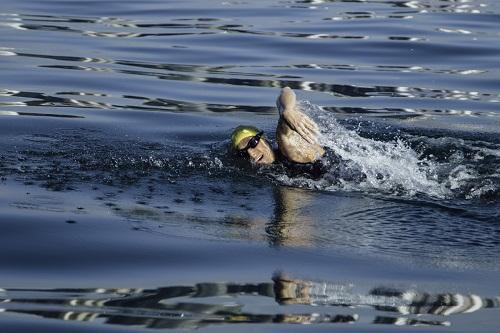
[301,102,448,197]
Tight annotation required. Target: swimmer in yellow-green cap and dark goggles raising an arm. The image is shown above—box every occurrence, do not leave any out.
[231,87,325,165]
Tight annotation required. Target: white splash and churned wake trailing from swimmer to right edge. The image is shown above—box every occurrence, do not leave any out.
[276,101,500,199]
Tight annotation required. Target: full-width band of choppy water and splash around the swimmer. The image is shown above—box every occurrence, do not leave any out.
[4,119,500,204]
